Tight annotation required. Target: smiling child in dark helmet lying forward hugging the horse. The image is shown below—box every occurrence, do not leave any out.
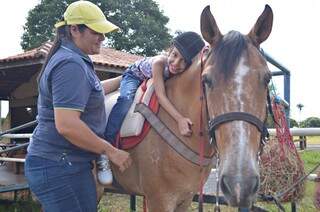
[97,32,205,184]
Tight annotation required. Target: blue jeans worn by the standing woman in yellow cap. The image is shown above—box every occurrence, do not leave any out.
[25,155,97,212]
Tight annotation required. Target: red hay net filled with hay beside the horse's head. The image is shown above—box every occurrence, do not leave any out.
[259,97,305,202]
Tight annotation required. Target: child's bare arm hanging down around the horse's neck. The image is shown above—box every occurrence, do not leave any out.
[152,56,192,136]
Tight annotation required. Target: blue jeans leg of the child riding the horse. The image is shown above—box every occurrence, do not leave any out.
[104,72,142,143]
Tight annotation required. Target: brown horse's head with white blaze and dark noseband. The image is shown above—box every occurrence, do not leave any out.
[201,5,273,207]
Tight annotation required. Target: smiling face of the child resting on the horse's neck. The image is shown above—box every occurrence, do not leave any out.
[168,47,187,74]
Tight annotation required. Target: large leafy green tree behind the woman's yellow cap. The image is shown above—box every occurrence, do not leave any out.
[21,0,172,56]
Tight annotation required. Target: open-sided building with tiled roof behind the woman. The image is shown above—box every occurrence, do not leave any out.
[0,42,140,133]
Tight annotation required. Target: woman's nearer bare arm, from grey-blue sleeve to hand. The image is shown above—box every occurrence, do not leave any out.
[54,108,131,171]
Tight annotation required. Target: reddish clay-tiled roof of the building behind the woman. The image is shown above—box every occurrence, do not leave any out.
[0,42,141,68]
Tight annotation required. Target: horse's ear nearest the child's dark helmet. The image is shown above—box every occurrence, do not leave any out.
[200,5,222,45]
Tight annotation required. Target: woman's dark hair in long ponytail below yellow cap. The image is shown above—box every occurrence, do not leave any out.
[37,24,87,84]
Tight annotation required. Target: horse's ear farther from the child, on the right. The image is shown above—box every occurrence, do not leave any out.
[248,4,273,46]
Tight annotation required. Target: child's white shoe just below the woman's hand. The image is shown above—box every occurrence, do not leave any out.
[97,155,112,185]
